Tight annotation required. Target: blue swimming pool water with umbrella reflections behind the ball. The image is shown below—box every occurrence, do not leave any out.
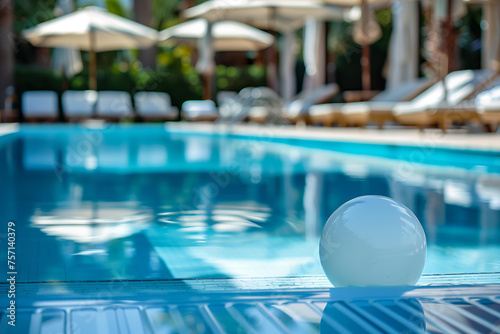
[0,125,500,282]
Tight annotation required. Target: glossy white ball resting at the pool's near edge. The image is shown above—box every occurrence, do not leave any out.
[319,196,427,287]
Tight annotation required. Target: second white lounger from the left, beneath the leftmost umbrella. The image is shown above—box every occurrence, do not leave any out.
[62,90,97,122]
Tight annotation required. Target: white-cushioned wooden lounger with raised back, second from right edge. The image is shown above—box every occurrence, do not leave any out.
[392,70,495,130]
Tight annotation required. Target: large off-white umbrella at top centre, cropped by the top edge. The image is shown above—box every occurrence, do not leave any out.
[185,0,348,96]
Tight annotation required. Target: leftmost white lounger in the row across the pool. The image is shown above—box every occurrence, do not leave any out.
[21,90,59,122]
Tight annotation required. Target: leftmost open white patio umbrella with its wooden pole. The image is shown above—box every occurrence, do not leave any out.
[23,7,158,90]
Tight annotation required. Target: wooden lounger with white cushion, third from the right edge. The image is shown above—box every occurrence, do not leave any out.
[309,78,431,126]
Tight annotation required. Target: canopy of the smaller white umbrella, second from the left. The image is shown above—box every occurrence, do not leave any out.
[159,19,274,51]
